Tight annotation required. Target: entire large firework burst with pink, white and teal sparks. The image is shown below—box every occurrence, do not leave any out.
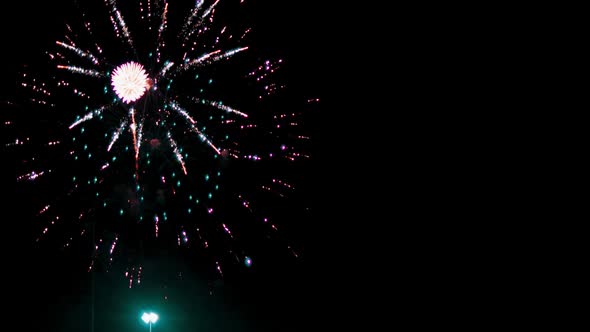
[6,0,318,287]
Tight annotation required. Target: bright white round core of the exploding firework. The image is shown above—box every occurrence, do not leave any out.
[111,62,150,104]
